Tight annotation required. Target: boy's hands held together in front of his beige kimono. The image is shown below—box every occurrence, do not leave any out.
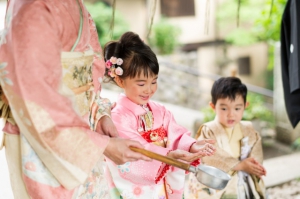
[234,157,267,178]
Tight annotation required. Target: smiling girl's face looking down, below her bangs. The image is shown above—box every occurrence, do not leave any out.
[120,74,158,105]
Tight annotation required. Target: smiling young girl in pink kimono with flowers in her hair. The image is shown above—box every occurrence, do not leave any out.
[104,32,215,199]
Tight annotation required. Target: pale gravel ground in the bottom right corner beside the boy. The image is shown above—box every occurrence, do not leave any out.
[267,179,300,199]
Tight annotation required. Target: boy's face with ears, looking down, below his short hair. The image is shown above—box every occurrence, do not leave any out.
[209,95,248,128]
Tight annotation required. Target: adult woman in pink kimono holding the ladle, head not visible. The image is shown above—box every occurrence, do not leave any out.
[0,0,149,199]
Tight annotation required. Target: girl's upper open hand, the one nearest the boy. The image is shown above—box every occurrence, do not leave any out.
[190,139,216,157]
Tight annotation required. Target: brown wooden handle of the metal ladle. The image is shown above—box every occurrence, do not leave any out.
[130,146,190,171]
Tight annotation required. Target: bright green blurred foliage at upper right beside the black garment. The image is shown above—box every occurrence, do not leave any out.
[217,0,287,89]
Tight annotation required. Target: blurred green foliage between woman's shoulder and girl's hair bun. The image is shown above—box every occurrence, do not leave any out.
[85,2,129,46]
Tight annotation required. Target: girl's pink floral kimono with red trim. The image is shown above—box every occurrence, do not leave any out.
[106,94,199,199]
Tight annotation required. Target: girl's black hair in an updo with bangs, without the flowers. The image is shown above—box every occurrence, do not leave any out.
[103,32,159,82]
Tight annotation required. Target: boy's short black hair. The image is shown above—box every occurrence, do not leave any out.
[211,77,247,105]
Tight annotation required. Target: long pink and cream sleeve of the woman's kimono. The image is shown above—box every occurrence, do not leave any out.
[0,1,109,189]
